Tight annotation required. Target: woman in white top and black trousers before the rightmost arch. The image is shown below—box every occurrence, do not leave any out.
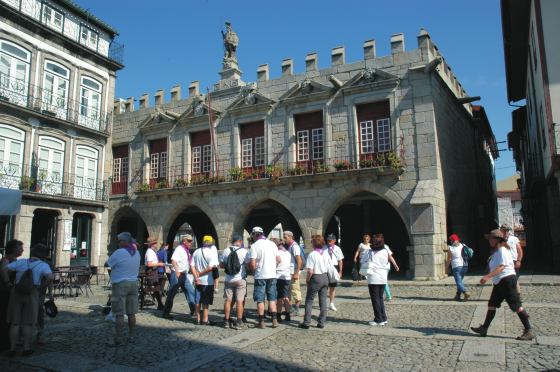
[362,234,389,326]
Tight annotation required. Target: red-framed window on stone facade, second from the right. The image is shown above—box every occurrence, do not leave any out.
[294,111,325,169]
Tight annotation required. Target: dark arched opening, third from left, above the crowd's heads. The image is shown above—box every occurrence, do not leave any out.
[243,199,303,247]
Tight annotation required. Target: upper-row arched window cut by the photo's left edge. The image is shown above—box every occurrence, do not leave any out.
[0,40,31,106]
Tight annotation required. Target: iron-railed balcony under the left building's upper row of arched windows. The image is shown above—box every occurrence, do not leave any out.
[0,73,112,136]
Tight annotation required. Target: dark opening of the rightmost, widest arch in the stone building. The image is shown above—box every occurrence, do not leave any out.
[324,191,410,277]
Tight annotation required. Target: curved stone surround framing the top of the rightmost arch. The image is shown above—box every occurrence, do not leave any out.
[317,180,413,246]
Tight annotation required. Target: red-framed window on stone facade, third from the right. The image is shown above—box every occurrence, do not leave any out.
[239,121,265,168]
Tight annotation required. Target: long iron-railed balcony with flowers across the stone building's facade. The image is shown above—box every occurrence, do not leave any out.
[112,137,406,195]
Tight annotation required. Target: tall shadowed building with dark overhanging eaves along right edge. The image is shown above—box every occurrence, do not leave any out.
[501,0,560,267]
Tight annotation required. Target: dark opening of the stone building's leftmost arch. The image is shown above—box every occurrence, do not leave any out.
[108,207,149,262]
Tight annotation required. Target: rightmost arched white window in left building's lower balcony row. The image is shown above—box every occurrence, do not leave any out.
[74,146,99,200]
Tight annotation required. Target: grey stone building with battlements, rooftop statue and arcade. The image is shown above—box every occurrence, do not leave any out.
[109,28,498,279]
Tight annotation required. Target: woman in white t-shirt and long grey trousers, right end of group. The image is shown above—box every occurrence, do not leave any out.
[298,235,331,329]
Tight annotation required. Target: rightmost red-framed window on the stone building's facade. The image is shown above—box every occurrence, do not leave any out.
[356,101,392,160]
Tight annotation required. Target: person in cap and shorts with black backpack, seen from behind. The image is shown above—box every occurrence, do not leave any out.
[220,235,251,329]
